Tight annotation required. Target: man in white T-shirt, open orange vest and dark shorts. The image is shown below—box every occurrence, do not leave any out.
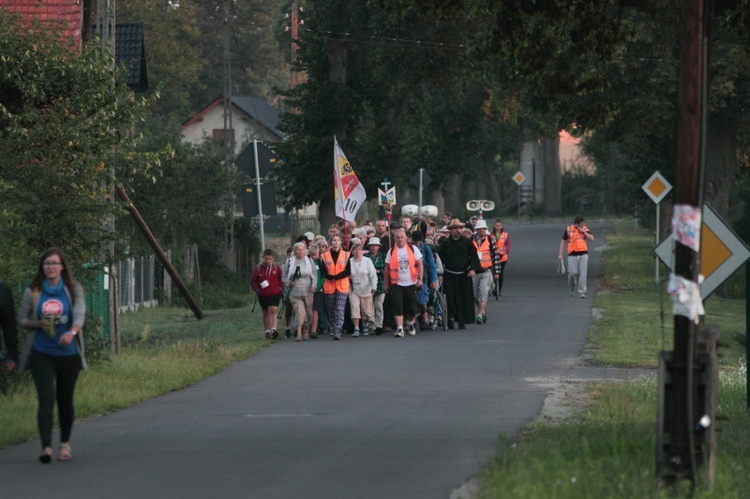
[383,229,424,338]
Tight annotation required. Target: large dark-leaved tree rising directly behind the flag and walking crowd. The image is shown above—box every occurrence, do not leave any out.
[278,0,524,225]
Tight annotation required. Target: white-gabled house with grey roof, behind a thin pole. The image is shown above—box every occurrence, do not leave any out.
[182,95,284,153]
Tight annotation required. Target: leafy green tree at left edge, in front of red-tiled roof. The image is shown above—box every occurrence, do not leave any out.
[0,10,153,270]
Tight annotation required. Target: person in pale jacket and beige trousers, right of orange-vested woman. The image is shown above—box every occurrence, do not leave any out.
[349,240,378,338]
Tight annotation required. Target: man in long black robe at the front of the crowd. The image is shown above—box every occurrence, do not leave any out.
[438,218,479,329]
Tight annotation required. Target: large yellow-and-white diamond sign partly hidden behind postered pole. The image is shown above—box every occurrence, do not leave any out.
[654,205,750,300]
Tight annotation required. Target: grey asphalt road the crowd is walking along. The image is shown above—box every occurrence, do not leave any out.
[0,223,604,499]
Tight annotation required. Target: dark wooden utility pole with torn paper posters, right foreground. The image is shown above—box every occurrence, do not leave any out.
[656,0,718,492]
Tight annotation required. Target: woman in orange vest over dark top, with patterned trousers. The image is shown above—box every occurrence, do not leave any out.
[320,235,352,340]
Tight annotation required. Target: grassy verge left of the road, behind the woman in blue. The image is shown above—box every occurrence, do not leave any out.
[0,297,265,446]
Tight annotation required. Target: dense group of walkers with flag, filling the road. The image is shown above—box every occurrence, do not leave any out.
[250,214,510,341]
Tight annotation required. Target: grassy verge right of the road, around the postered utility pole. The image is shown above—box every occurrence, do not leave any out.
[479,223,750,499]
